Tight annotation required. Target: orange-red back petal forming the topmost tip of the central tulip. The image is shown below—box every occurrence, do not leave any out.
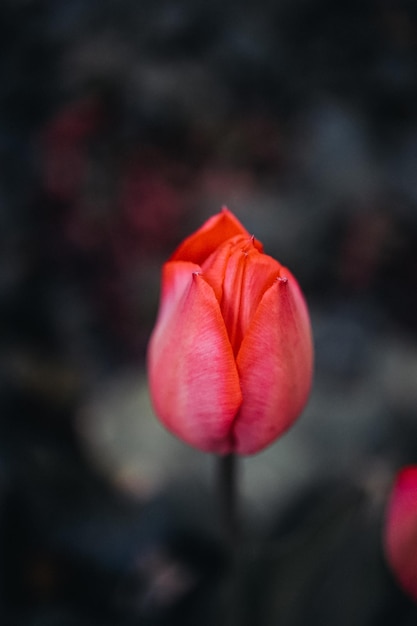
[170,208,261,265]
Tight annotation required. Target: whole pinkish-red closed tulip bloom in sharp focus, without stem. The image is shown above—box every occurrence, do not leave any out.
[148,209,313,454]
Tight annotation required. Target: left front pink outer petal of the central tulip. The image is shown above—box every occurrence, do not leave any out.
[148,262,242,454]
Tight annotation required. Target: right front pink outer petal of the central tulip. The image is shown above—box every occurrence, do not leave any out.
[232,268,313,454]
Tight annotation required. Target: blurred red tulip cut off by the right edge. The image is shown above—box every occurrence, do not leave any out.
[384,465,417,600]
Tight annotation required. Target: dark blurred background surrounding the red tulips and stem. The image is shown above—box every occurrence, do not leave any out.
[0,0,417,626]
